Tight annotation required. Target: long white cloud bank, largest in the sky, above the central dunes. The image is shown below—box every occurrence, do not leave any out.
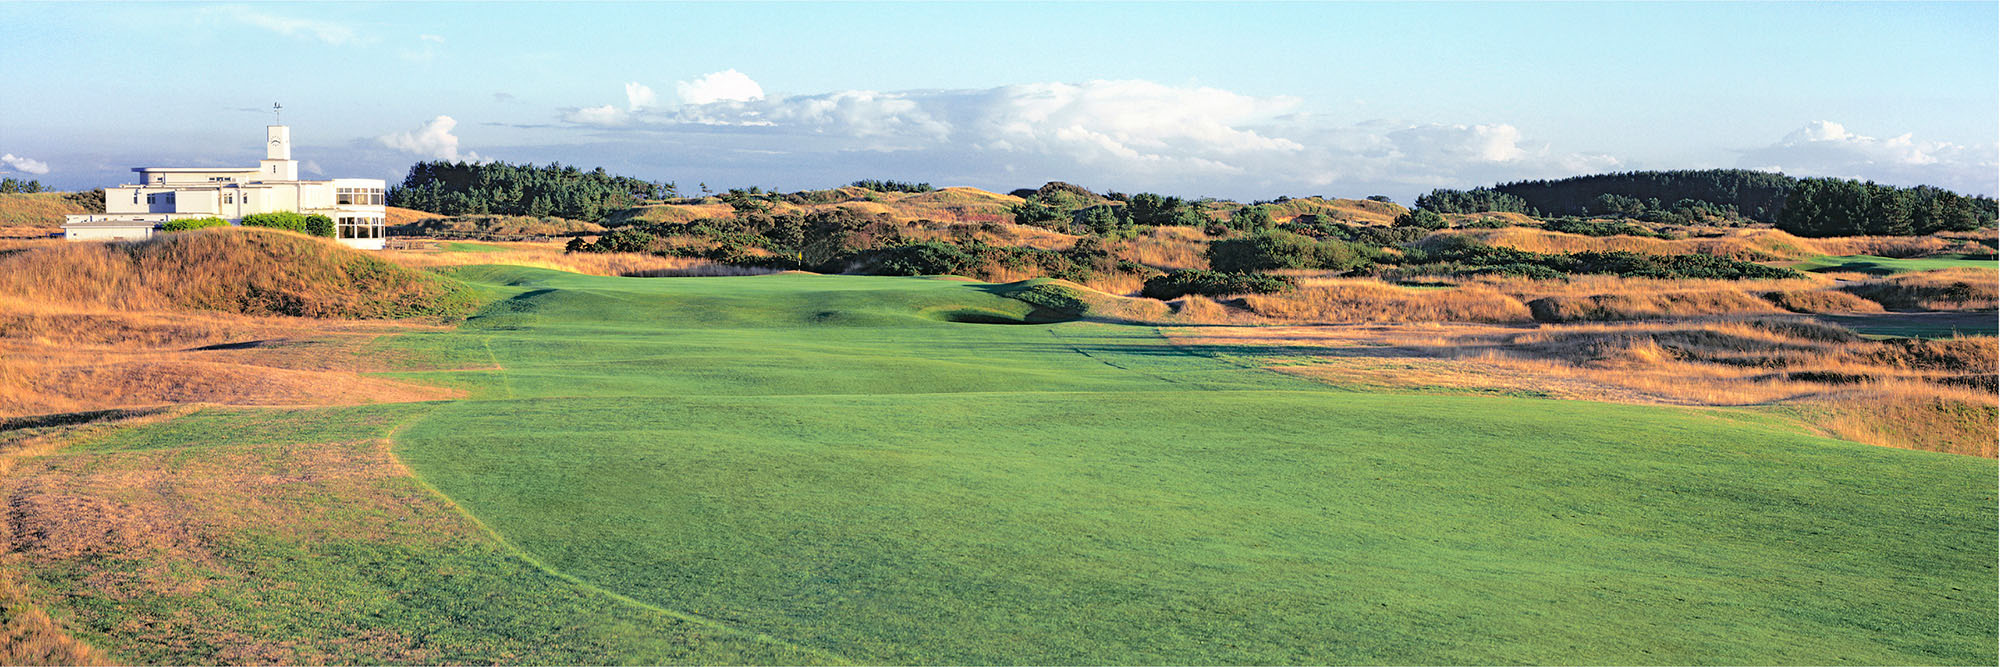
[562,72,1620,196]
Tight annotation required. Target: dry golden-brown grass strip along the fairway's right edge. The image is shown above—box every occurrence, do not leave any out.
[1164,318,2000,457]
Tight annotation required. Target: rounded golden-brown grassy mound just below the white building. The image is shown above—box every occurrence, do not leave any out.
[0,228,478,320]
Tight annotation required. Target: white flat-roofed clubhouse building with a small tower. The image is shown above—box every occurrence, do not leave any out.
[62,126,384,250]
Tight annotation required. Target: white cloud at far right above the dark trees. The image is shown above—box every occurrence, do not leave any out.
[1738,120,2000,192]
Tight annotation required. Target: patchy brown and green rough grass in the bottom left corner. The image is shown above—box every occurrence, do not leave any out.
[0,405,824,665]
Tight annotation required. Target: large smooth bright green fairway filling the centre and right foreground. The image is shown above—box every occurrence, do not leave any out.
[372,268,1996,663]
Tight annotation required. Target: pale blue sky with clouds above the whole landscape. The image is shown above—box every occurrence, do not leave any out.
[0,2,2000,202]
